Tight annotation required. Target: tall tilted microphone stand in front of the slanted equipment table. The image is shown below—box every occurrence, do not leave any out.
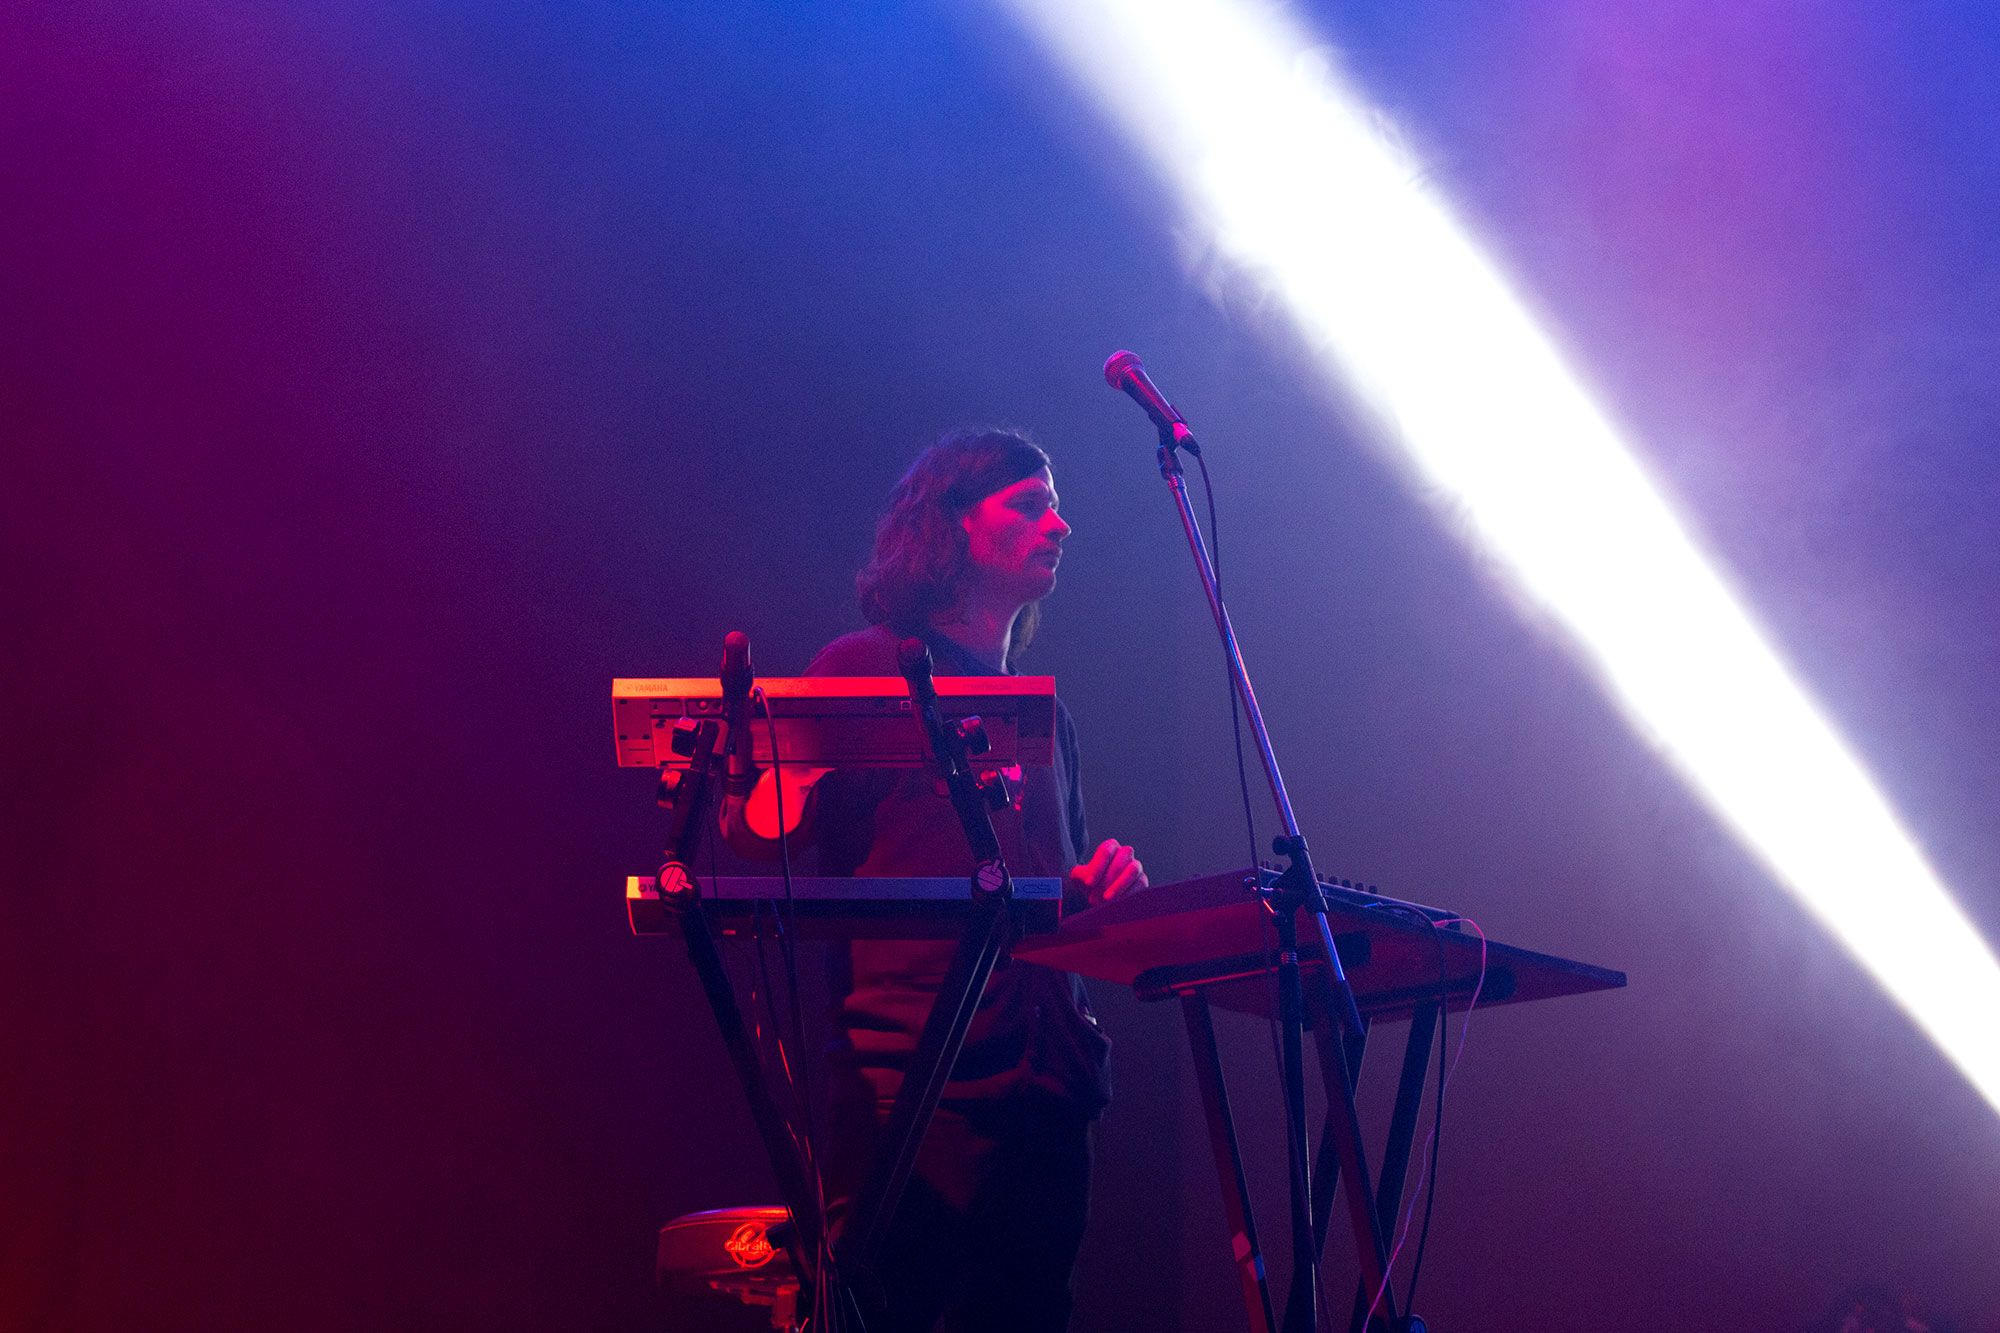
[1158,424,1402,1333]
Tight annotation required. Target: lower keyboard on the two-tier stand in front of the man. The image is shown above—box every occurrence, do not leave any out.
[626,875,1062,939]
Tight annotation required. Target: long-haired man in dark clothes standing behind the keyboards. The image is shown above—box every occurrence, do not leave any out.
[726,430,1146,1333]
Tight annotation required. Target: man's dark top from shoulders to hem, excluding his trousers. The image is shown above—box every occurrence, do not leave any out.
[806,626,1110,1117]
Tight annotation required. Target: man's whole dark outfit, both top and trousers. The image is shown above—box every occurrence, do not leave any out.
[792,626,1110,1333]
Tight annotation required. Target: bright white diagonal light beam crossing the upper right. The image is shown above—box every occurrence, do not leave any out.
[1002,0,2000,1111]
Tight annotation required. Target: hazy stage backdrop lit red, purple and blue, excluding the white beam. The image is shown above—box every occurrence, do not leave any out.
[0,0,2000,1331]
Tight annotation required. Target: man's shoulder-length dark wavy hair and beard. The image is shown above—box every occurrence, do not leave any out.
[854,426,1048,656]
